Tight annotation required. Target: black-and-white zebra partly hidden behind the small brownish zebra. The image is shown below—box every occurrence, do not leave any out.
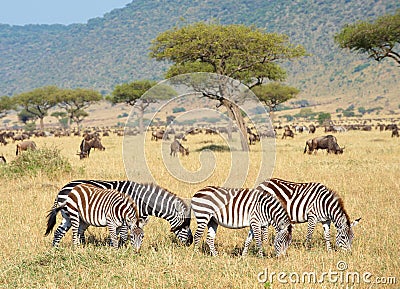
[48,180,193,246]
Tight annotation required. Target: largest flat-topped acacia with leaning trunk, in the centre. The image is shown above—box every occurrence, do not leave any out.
[150,22,306,151]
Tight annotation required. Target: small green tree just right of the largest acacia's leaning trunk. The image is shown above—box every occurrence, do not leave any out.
[252,82,300,112]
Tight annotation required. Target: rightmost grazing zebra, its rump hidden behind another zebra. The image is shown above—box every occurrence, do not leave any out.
[257,179,361,251]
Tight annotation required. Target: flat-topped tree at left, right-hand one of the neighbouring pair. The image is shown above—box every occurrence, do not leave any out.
[57,88,102,131]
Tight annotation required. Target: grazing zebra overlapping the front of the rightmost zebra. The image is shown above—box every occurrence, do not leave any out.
[192,186,292,256]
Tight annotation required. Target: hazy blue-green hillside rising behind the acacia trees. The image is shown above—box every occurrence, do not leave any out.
[0,0,400,115]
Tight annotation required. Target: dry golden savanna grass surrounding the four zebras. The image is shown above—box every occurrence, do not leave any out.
[0,129,400,288]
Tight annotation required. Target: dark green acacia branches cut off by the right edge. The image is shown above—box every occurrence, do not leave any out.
[334,9,400,64]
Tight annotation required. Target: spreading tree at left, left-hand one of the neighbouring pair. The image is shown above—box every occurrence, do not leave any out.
[14,86,59,130]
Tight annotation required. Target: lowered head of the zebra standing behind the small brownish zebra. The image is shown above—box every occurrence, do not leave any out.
[171,201,193,246]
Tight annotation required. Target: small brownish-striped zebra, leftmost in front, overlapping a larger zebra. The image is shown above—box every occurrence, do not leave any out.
[45,184,144,252]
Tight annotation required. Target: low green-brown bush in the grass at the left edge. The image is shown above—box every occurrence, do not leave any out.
[0,148,72,177]
